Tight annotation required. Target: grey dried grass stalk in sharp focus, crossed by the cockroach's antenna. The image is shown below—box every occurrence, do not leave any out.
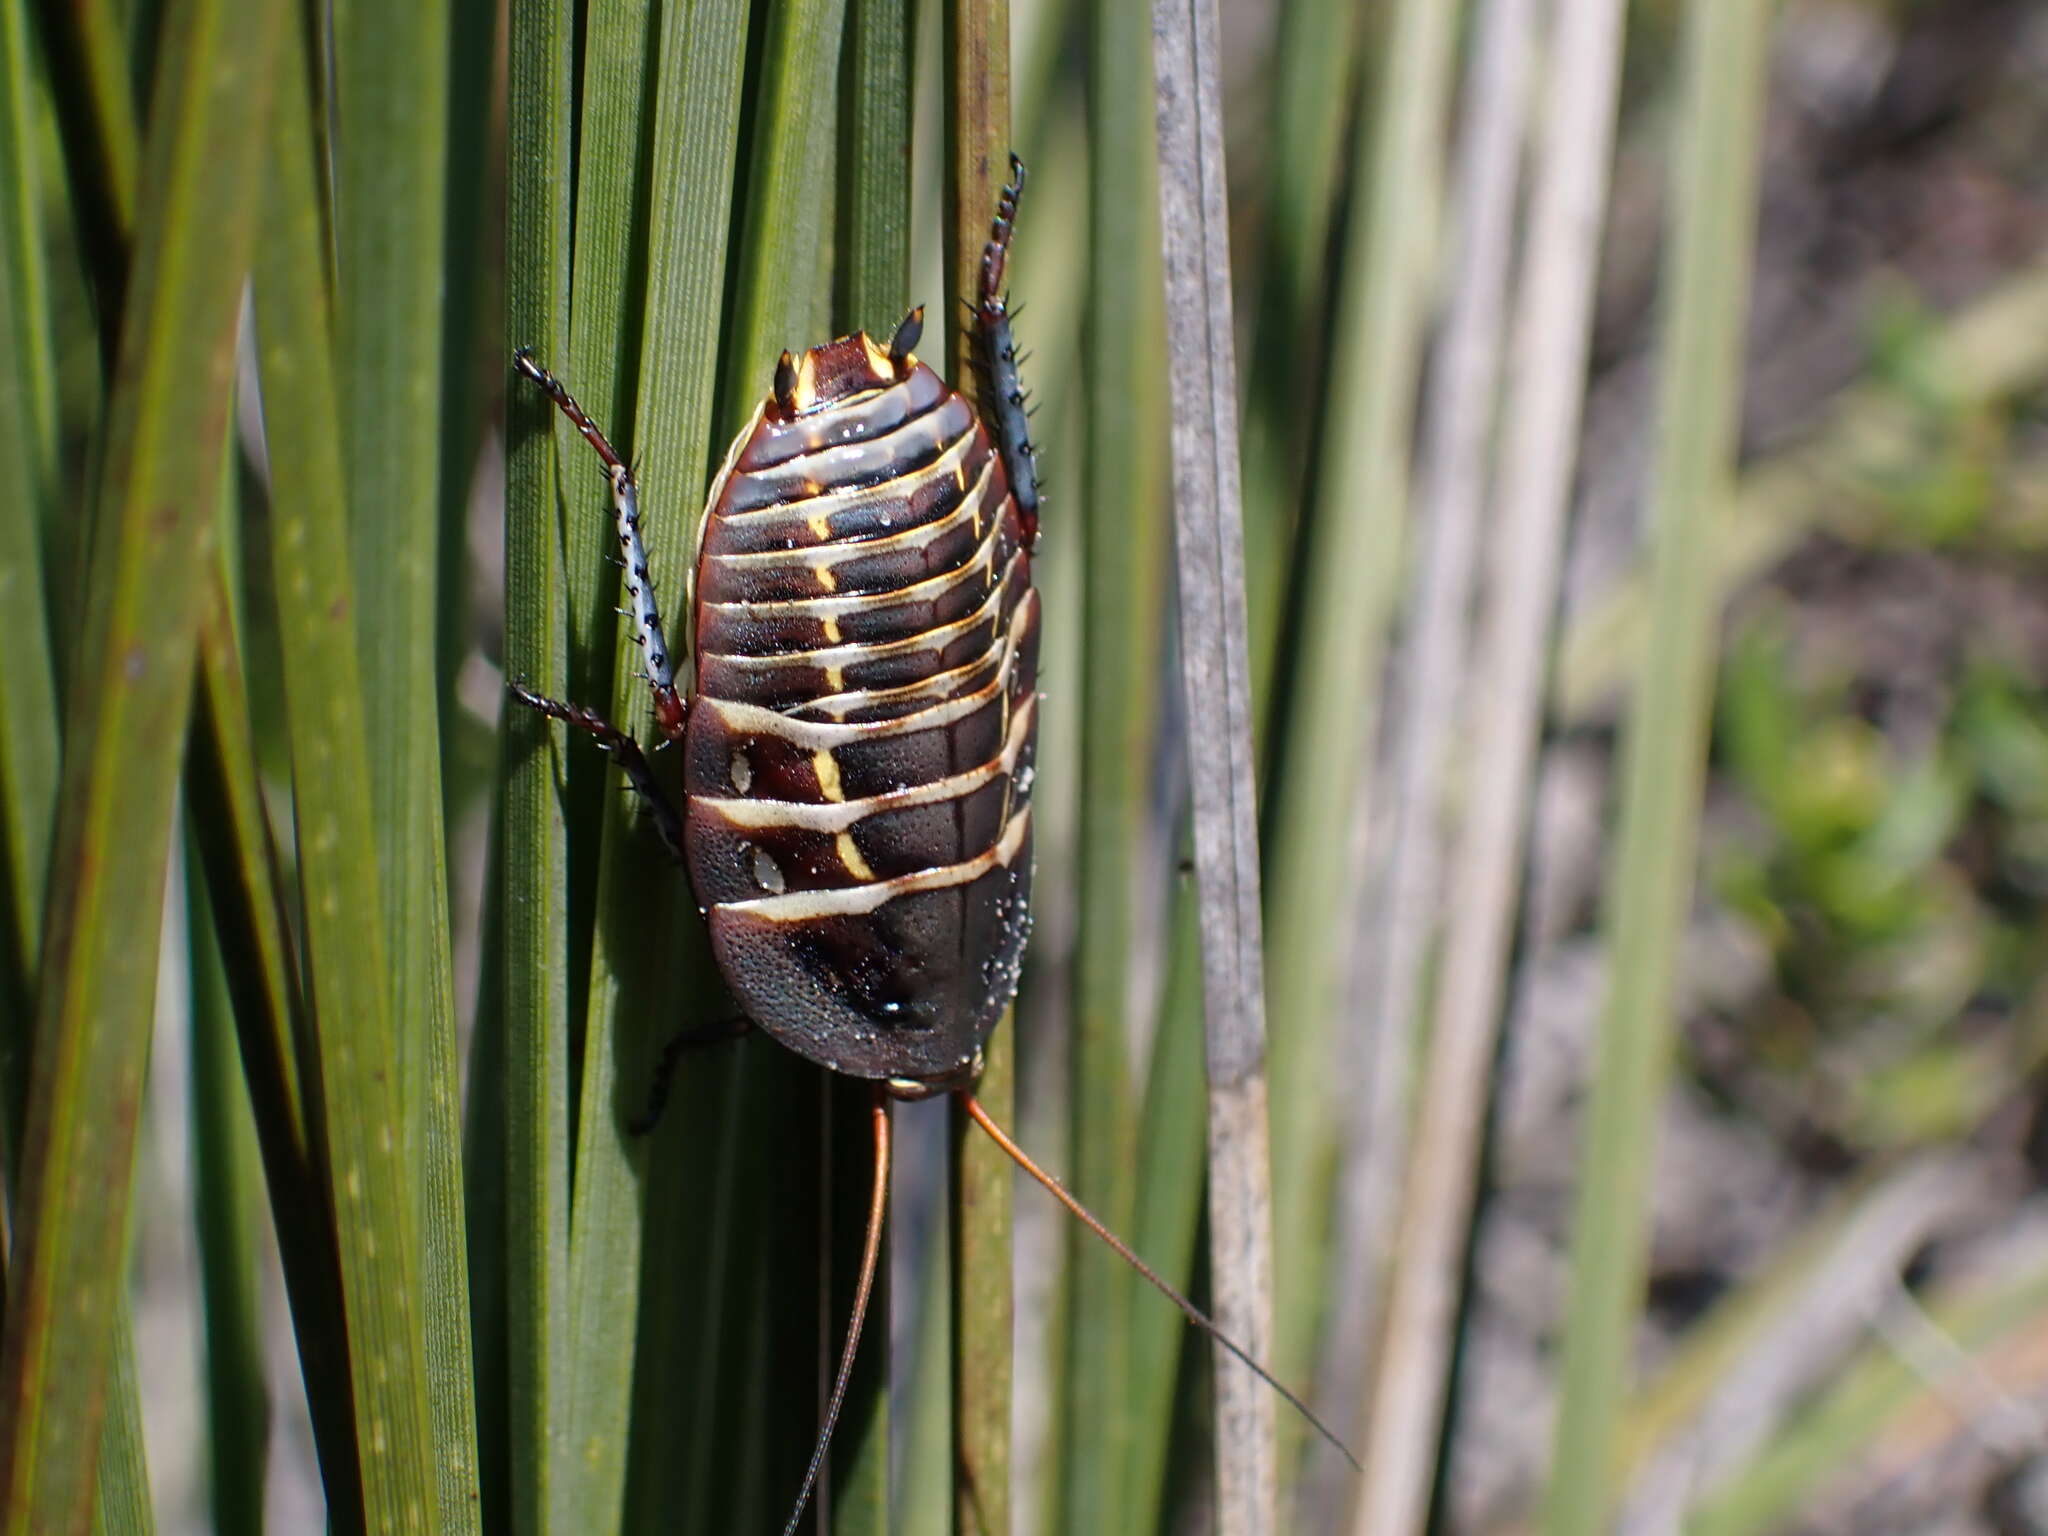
[1153,0,1278,1536]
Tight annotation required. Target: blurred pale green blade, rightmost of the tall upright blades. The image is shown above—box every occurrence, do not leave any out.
[1542,0,1772,1536]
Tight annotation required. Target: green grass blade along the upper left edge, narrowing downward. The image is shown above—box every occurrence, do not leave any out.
[0,0,59,1048]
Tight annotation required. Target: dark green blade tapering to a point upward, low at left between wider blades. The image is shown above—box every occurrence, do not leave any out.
[186,838,270,1536]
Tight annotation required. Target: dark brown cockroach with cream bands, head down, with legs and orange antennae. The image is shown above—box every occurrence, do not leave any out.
[512,156,1350,1532]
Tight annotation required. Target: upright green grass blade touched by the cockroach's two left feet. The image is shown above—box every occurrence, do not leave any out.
[503,0,575,1536]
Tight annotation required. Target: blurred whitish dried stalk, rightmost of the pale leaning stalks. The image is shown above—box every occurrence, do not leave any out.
[1356,0,1622,1532]
